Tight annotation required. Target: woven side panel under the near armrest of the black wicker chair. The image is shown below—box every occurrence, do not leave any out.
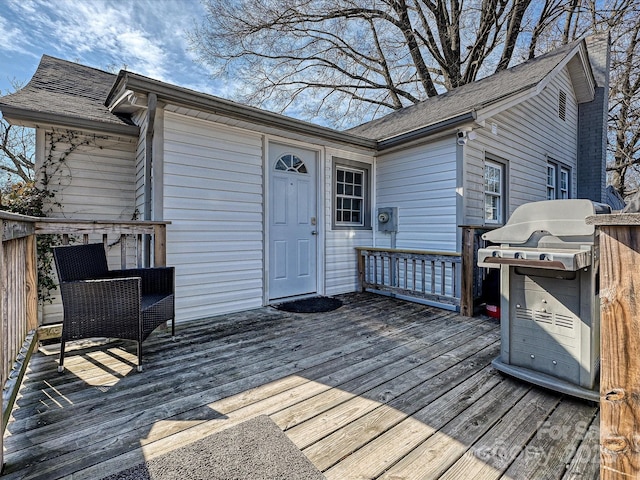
[60,277,142,340]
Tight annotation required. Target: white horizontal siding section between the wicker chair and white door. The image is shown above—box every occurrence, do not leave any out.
[163,112,263,320]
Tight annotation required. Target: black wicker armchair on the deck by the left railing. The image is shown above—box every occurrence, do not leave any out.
[53,243,175,372]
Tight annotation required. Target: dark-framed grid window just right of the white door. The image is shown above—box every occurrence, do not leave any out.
[332,158,371,229]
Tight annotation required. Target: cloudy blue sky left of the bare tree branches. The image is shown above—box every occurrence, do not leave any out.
[0,0,226,96]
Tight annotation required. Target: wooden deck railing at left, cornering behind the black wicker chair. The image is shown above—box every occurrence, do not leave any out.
[0,212,169,466]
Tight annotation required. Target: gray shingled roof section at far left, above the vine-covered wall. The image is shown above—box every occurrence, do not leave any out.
[0,55,132,125]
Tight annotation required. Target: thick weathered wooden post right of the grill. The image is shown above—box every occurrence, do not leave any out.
[587,214,640,480]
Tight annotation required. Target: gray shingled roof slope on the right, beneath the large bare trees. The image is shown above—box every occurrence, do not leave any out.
[347,41,580,140]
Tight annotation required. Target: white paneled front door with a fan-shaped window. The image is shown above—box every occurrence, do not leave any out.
[269,143,318,300]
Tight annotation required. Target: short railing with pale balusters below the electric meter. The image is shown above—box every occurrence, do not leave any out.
[356,247,462,307]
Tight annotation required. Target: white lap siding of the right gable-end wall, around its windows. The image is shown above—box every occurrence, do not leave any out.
[460,65,578,225]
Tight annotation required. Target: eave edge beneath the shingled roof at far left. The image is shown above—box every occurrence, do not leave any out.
[0,105,140,136]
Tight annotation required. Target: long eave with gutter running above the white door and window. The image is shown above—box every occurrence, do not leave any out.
[106,72,377,150]
